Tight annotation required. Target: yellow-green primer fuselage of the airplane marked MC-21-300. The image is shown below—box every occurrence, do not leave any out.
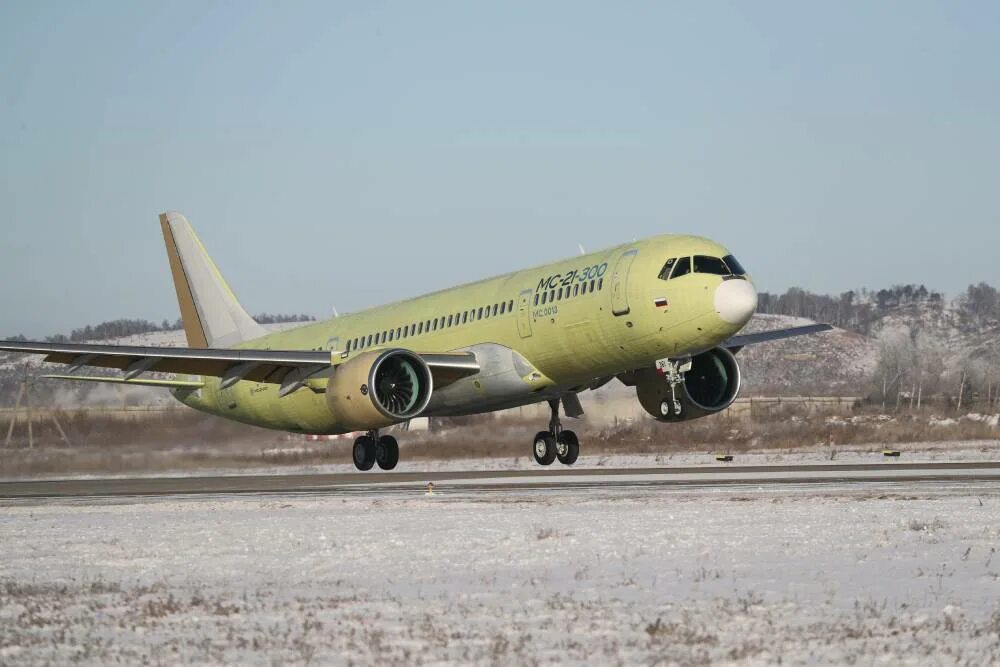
[174,235,749,433]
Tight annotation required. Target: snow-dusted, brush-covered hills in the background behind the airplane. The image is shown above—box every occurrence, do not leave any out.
[0,283,1000,408]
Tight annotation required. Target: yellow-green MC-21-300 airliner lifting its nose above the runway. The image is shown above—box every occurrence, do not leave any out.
[0,212,832,470]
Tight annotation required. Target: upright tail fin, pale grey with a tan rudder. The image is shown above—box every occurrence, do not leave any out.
[160,212,267,348]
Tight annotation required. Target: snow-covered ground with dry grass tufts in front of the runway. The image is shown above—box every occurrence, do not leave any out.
[0,484,1000,664]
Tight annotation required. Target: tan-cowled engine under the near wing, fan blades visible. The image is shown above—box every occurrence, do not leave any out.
[326,349,434,431]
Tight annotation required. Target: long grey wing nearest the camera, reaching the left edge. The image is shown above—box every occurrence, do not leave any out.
[0,341,479,396]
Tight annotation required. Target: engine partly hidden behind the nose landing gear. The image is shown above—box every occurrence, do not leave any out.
[635,347,742,422]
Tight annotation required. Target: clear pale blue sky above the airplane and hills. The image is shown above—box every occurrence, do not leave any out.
[0,0,1000,336]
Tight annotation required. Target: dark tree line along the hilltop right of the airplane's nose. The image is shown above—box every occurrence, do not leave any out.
[757,283,1000,335]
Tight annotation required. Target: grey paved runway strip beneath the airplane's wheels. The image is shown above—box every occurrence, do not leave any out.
[0,461,1000,500]
